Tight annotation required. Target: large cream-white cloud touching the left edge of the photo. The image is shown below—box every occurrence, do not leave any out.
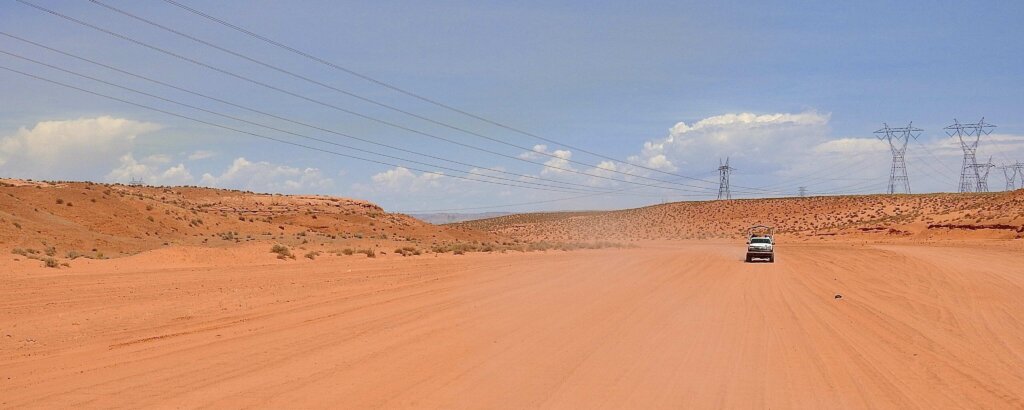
[0,116,161,178]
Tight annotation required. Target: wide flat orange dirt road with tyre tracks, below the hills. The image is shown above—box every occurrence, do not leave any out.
[0,242,1024,409]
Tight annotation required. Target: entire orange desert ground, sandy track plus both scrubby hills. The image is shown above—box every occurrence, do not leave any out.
[0,180,1024,409]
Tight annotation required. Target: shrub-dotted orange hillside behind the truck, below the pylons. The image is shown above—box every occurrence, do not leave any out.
[455,190,1024,242]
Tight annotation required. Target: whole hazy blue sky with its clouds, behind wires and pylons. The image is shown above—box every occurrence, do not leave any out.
[0,0,1024,210]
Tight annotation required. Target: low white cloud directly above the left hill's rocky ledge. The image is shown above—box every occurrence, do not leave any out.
[200,157,334,193]
